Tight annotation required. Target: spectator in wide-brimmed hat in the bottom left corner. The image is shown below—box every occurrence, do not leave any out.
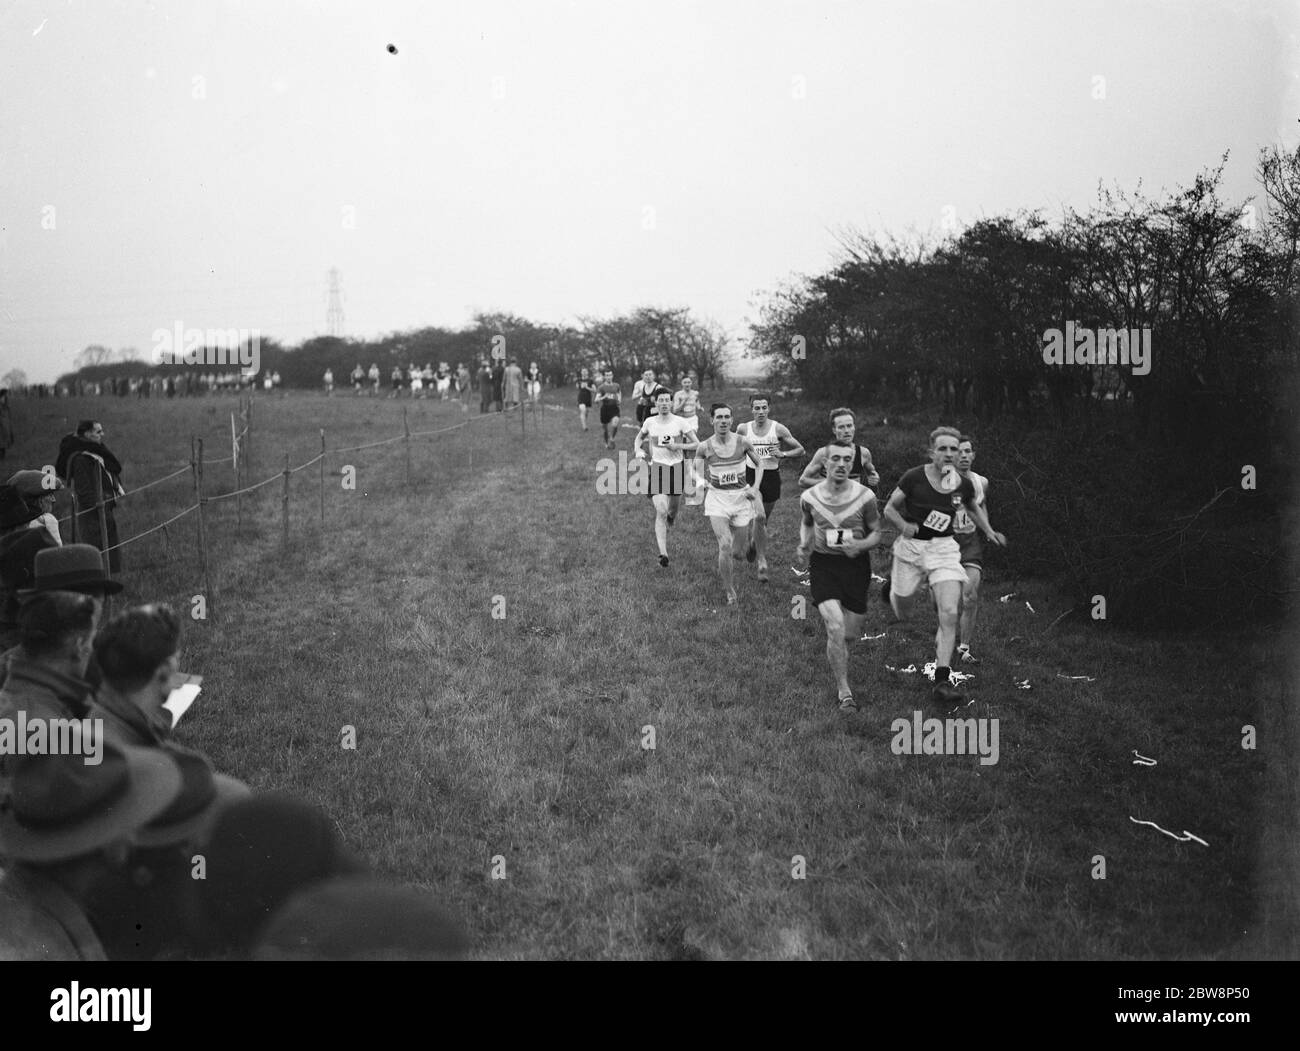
[0,745,182,960]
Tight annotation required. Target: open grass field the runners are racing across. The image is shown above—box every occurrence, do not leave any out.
[8,393,1297,960]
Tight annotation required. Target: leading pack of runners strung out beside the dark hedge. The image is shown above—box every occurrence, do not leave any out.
[579,369,1006,712]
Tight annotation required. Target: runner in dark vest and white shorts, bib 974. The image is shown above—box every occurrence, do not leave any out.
[884,427,1006,704]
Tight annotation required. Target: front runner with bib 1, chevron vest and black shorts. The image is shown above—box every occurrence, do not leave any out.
[794,438,880,712]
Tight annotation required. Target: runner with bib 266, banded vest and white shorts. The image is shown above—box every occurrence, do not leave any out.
[690,402,763,606]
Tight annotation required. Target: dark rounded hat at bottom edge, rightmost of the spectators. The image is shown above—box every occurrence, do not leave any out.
[252,875,469,960]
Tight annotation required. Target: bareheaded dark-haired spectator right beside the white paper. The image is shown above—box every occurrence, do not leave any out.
[91,604,181,748]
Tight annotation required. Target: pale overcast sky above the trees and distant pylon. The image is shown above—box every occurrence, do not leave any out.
[0,0,1300,381]
